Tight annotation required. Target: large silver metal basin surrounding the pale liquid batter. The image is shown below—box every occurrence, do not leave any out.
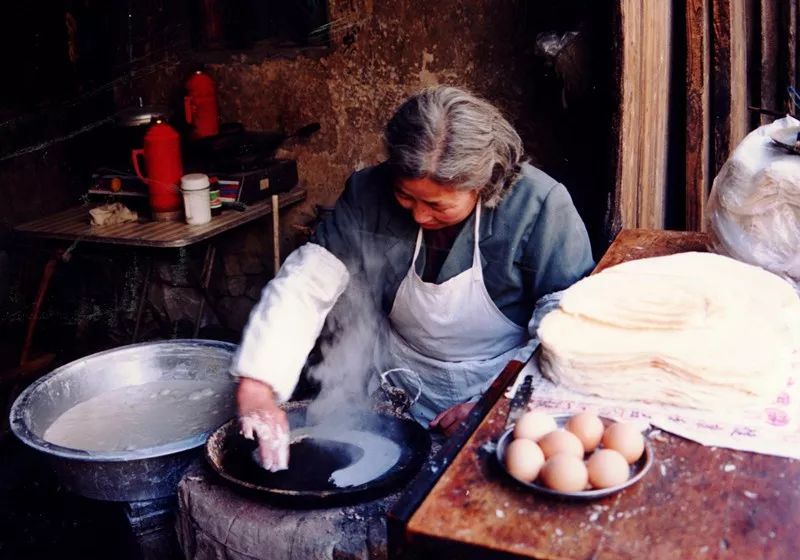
[10,340,236,502]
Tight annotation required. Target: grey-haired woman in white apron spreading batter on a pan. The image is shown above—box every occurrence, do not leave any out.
[232,87,593,470]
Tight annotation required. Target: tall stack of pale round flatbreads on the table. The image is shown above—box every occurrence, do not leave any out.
[538,253,800,409]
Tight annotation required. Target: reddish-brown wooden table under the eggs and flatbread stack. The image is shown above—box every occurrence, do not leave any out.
[389,230,800,560]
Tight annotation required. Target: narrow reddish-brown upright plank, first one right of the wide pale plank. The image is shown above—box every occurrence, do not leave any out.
[685,0,711,231]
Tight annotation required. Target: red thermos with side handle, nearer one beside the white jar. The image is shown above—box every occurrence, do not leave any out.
[131,121,183,221]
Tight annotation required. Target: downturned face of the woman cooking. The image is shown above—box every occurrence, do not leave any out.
[394,177,478,229]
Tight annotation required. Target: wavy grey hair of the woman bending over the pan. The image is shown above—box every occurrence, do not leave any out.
[384,86,523,207]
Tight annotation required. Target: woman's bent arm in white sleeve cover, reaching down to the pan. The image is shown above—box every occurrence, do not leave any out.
[231,174,372,471]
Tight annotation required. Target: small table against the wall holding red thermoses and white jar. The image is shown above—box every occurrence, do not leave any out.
[14,188,306,364]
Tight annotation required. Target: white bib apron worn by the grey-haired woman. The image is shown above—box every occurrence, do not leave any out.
[386,203,528,424]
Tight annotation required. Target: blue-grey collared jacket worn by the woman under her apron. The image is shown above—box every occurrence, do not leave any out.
[312,164,594,326]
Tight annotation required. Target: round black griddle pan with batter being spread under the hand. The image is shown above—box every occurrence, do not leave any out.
[206,402,431,507]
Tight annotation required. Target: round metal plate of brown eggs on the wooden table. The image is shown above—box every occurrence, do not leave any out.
[496,411,653,500]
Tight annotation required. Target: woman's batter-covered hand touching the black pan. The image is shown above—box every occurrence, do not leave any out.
[236,377,289,472]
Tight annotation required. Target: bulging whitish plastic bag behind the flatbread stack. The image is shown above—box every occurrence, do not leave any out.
[707,116,800,289]
